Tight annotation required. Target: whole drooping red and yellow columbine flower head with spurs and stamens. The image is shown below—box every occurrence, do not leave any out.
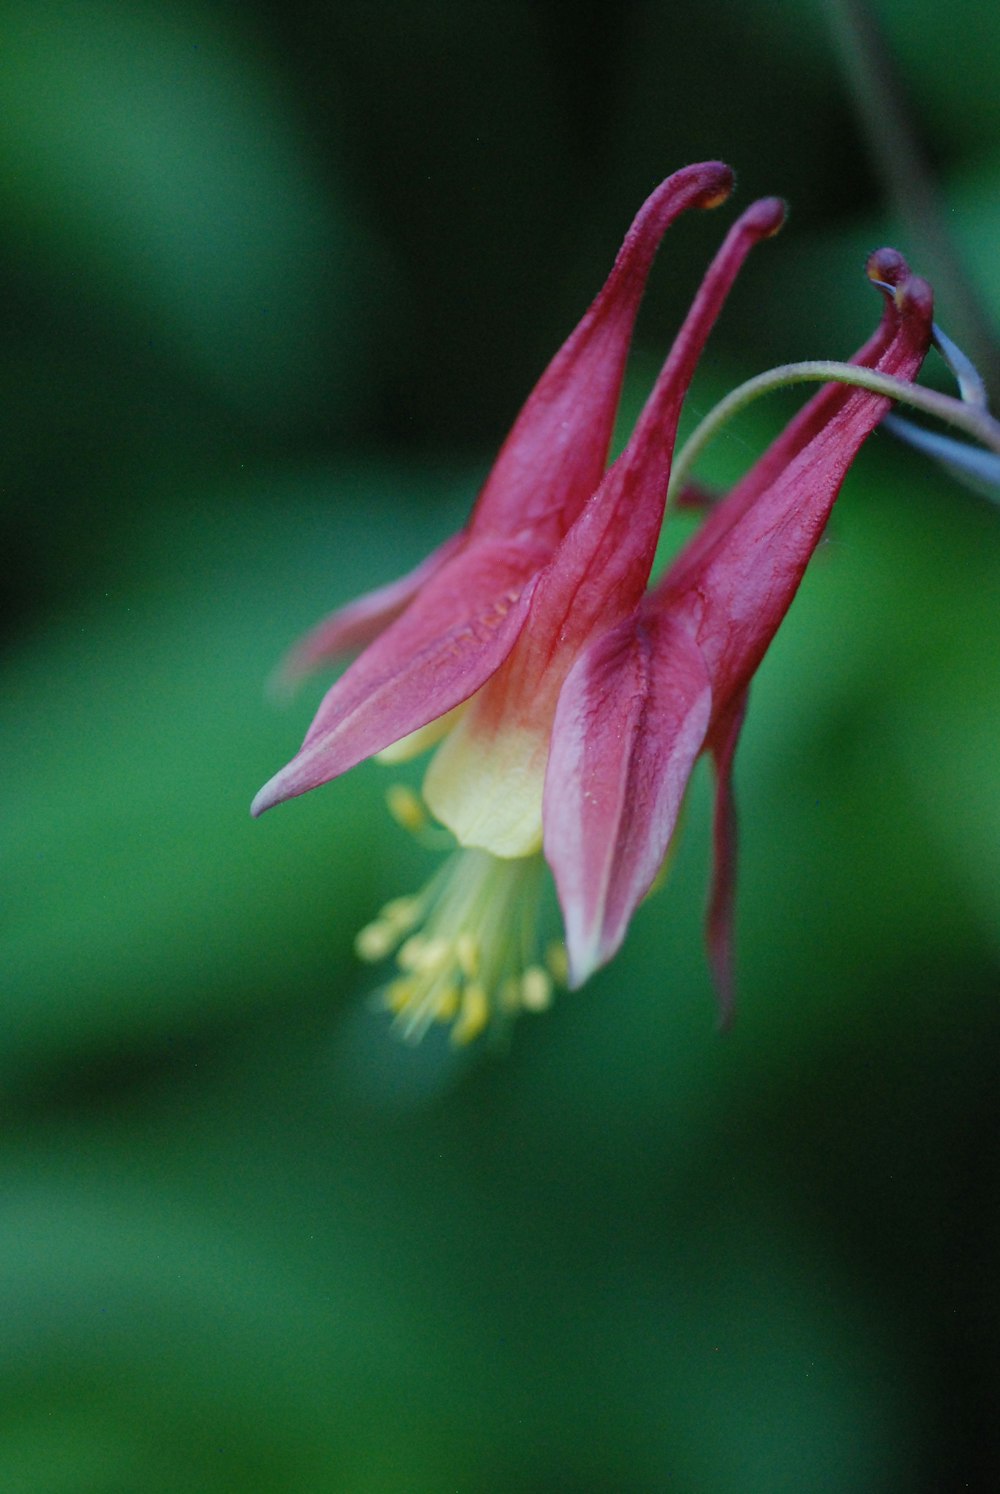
[254,163,922,1040]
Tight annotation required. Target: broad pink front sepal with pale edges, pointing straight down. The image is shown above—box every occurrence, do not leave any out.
[544,613,712,986]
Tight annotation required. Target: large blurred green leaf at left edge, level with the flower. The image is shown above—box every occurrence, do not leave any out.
[0,471,469,1087]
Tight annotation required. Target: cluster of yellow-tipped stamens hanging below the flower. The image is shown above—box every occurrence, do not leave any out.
[354,830,567,1044]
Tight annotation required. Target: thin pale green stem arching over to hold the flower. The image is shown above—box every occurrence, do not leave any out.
[670,360,1000,495]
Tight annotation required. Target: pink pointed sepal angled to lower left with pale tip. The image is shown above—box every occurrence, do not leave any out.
[251,539,540,814]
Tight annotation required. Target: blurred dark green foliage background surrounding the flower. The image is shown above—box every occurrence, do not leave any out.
[0,0,1000,1494]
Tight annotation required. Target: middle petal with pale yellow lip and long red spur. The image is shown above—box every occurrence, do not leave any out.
[425,197,785,856]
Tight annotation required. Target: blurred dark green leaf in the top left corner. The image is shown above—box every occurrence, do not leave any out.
[0,0,371,423]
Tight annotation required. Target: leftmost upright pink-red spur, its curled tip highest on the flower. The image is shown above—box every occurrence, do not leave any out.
[469,161,732,544]
